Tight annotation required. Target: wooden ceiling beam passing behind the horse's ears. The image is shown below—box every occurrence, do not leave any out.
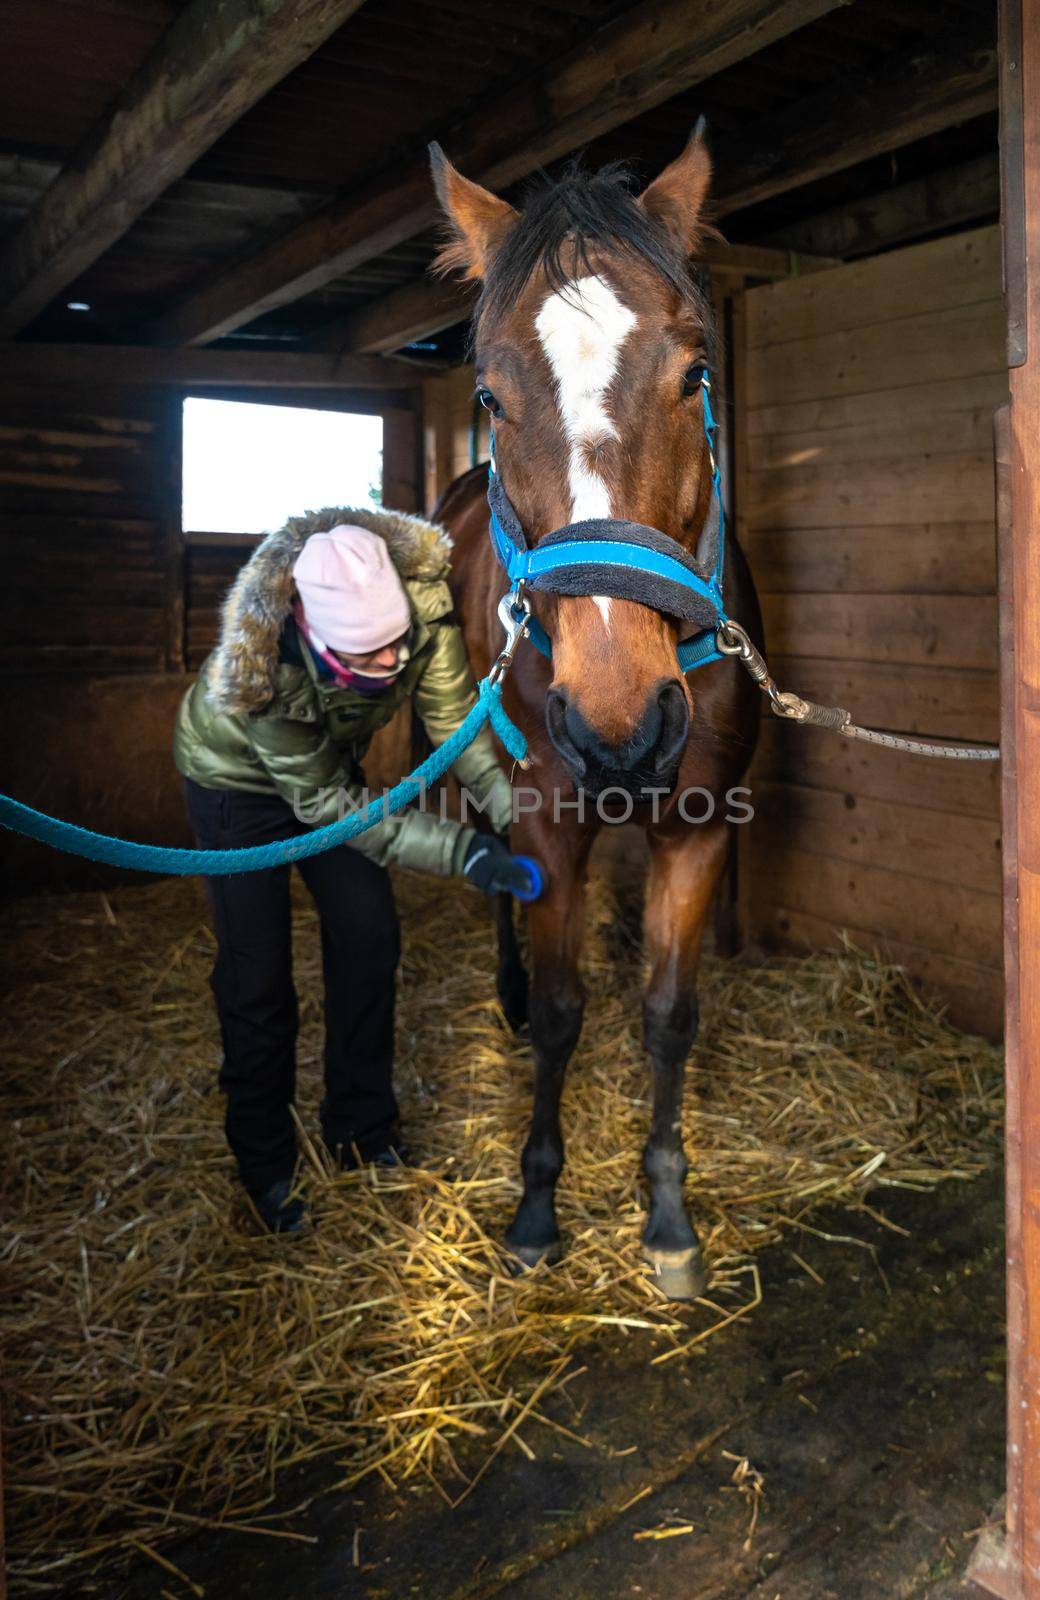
[328,242,837,355]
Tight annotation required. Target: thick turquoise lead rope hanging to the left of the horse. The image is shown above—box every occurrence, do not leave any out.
[0,678,526,877]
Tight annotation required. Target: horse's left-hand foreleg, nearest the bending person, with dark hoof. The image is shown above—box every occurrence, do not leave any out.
[506,827,589,1267]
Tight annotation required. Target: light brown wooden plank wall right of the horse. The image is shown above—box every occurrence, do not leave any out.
[734,227,1006,1034]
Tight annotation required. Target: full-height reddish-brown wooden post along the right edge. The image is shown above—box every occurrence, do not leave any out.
[971,0,1040,1600]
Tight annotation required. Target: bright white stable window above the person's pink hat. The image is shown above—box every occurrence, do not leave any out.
[181,397,382,534]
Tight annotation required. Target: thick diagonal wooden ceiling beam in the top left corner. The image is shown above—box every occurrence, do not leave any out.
[0,0,371,338]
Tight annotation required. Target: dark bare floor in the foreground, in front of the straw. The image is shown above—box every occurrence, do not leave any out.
[99,1176,1003,1600]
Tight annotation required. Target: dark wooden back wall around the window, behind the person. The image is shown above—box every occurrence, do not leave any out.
[0,386,421,890]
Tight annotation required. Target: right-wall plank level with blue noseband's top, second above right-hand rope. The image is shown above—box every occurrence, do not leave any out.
[746,522,997,595]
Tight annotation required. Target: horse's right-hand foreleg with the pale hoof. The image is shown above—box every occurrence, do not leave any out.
[643,824,728,1299]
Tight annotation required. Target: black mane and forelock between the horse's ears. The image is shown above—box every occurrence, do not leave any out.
[474,163,714,355]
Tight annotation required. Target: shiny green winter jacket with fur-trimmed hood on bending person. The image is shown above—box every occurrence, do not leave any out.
[173,507,512,875]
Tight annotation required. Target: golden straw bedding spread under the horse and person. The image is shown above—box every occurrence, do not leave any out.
[0,875,1000,1592]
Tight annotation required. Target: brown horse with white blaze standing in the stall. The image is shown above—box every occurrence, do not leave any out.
[432,130,760,1298]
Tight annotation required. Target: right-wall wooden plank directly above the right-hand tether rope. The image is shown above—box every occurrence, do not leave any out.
[762,594,998,675]
